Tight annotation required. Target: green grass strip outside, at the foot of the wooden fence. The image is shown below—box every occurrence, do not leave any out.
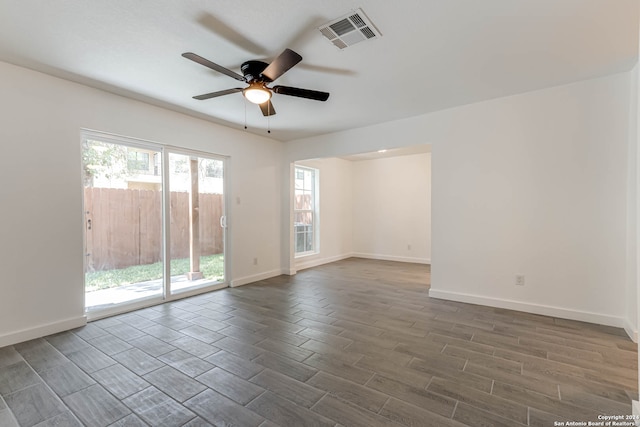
[85,254,224,292]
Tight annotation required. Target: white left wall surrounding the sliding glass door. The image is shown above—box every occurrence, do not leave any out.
[0,63,282,347]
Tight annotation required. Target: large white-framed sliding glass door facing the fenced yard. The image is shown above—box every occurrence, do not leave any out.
[82,132,226,315]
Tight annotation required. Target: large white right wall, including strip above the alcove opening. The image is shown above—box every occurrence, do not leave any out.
[285,73,630,332]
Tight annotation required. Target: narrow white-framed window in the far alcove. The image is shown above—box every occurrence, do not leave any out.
[293,166,318,256]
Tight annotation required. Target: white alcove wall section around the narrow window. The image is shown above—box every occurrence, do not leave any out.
[295,158,353,270]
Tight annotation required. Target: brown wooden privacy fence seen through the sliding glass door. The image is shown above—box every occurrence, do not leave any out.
[84,187,224,271]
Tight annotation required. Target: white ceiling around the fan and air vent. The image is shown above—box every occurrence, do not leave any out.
[0,0,638,141]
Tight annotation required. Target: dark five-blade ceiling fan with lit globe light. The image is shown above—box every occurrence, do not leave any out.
[182,49,329,116]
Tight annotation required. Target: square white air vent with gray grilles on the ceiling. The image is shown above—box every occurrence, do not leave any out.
[319,9,382,49]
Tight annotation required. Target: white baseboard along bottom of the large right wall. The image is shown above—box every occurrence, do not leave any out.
[429,288,624,328]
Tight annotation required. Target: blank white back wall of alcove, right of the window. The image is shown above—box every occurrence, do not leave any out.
[353,153,431,264]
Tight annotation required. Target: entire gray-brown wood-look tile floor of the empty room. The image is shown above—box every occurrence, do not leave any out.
[0,258,638,427]
